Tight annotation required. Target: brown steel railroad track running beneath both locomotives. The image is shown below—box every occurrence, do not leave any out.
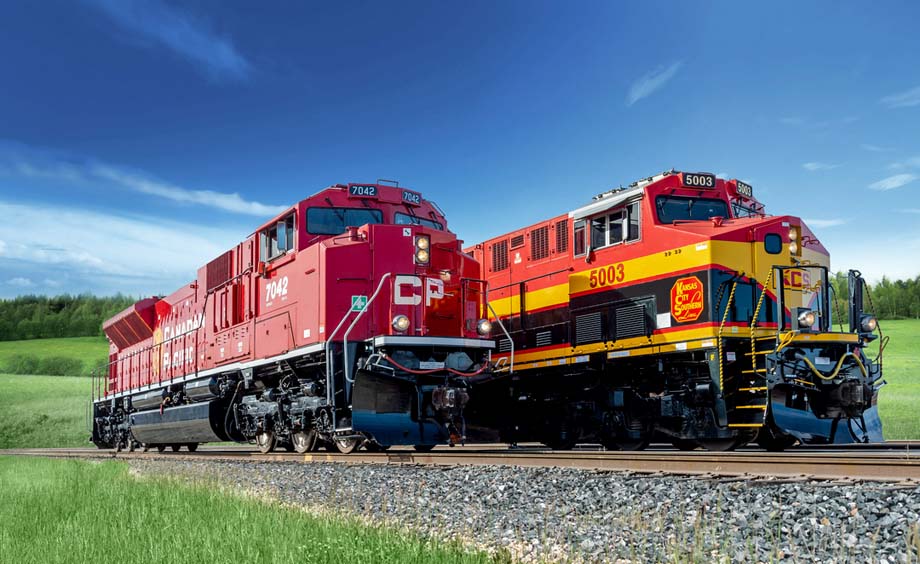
[7,442,920,486]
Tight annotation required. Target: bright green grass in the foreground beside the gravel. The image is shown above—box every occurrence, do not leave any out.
[0,457,493,564]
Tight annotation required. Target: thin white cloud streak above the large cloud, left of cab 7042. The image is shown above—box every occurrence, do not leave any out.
[92,165,287,216]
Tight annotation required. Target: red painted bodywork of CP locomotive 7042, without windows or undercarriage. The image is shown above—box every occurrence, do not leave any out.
[102,185,484,397]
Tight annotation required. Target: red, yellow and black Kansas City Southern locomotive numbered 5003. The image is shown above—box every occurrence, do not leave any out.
[468,171,882,450]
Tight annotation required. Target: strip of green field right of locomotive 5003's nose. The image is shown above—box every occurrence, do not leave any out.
[871,319,920,440]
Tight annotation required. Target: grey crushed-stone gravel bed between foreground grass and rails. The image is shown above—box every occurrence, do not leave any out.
[130,459,920,563]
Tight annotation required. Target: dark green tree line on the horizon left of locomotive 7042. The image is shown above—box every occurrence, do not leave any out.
[0,294,136,341]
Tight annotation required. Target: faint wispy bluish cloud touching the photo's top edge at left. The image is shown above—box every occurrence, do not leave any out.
[85,0,252,80]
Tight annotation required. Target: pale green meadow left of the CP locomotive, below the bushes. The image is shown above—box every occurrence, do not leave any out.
[0,374,91,450]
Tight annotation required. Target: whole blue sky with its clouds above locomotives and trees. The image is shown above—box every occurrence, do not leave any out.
[0,0,920,297]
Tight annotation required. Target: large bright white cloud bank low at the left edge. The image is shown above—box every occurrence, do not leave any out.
[0,201,243,291]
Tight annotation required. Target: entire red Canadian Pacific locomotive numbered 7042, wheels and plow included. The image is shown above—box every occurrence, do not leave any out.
[92,183,494,452]
